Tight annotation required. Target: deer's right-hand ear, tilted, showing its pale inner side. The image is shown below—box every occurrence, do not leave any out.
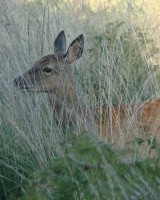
[65,35,84,64]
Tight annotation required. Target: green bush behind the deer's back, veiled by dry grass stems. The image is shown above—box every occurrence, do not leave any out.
[79,18,156,104]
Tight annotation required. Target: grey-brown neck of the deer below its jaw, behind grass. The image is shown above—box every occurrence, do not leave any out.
[48,74,83,125]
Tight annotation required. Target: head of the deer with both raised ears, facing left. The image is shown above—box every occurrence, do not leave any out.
[14,31,84,93]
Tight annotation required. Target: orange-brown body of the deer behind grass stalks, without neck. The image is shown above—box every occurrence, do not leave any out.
[101,99,160,143]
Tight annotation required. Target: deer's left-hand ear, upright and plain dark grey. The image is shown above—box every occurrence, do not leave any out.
[54,31,66,56]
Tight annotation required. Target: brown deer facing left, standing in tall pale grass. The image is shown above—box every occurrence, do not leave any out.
[14,30,160,157]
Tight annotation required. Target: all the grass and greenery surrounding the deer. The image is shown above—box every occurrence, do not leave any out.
[0,0,160,200]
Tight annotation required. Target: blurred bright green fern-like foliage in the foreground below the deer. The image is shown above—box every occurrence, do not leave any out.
[22,135,160,200]
